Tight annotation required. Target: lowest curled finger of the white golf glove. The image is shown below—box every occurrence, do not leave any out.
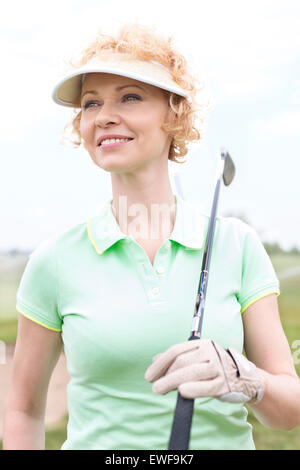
[178,376,228,399]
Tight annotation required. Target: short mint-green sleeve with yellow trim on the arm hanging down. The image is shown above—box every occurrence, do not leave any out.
[16,242,62,331]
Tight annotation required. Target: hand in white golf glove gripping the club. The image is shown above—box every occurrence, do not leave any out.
[145,339,264,403]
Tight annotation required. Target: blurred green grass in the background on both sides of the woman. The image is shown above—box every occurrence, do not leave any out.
[0,255,300,450]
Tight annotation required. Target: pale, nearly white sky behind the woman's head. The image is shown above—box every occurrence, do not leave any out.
[0,0,300,251]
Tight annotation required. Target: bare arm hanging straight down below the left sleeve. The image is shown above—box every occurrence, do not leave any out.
[3,315,63,450]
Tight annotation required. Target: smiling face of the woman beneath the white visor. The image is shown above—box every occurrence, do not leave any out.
[80,73,172,173]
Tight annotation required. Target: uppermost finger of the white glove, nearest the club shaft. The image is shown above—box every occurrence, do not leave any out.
[144,339,201,382]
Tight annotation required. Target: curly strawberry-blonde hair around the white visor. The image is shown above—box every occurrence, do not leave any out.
[62,23,210,163]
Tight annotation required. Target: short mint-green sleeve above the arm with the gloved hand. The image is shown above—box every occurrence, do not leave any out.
[237,226,280,313]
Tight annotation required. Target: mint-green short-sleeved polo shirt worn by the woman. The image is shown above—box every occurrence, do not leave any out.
[17,195,279,450]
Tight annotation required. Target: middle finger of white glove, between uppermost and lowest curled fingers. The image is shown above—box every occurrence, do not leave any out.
[152,362,218,395]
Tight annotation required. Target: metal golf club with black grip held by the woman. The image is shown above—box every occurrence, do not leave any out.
[168,147,235,450]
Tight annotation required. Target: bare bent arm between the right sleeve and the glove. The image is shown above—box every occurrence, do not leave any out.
[243,294,300,430]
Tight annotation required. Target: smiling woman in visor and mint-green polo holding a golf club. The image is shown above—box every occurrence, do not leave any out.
[3,25,300,449]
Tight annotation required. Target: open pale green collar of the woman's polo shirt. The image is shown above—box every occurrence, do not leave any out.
[87,194,204,254]
